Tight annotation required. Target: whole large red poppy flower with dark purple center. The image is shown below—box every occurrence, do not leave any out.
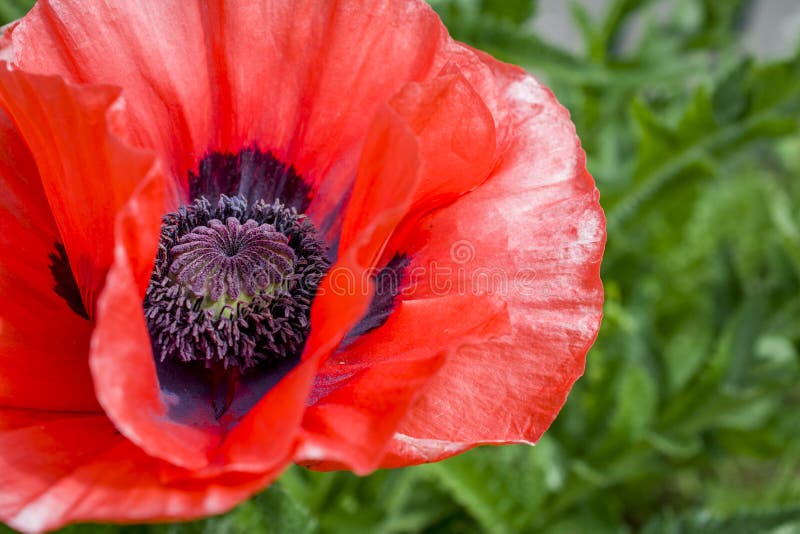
[0,0,605,531]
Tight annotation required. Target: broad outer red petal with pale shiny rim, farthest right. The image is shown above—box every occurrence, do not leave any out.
[383,56,605,466]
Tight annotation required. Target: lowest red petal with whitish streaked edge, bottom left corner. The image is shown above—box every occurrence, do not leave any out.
[0,409,277,532]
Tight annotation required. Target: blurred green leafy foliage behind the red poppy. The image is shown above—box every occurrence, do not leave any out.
[0,0,800,534]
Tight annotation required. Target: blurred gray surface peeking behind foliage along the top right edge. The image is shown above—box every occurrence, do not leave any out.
[532,0,800,58]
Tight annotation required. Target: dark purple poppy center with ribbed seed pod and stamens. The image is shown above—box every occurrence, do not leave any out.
[144,196,330,374]
